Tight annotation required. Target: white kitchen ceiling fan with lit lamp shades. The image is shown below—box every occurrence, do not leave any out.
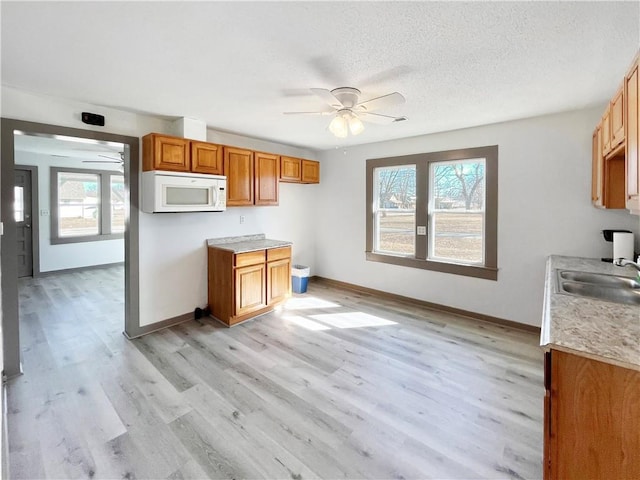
[284,87,407,138]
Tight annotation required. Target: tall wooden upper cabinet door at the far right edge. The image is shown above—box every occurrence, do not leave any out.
[625,59,640,212]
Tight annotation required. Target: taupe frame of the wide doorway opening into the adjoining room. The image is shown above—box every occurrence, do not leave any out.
[0,118,141,378]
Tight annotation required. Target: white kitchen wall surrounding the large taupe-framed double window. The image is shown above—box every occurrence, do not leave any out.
[315,107,640,325]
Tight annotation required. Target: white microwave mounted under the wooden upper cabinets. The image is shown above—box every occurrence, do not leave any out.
[142,170,227,213]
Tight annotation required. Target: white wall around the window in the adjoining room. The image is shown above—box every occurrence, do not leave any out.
[15,151,124,272]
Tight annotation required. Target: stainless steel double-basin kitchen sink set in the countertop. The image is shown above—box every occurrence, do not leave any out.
[557,270,640,305]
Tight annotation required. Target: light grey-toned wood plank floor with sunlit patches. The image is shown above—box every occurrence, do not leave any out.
[8,268,543,480]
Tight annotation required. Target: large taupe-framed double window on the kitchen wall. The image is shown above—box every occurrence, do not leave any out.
[366,146,498,280]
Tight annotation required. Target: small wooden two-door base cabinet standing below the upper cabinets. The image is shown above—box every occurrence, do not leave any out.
[207,247,291,326]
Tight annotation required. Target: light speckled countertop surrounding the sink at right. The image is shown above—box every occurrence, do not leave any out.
[540,255,640,370]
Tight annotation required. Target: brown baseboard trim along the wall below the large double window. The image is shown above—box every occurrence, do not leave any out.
[309,275,540,335]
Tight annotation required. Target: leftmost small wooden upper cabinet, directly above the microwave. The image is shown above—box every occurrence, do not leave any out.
[142,133,191,172]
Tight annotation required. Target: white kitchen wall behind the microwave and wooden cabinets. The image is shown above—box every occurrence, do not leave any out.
[1,87,319,326]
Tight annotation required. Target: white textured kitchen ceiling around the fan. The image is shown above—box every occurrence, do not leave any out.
[0,1,640,150]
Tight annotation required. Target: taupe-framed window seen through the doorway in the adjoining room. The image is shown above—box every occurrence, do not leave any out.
[51,167,126,244]
